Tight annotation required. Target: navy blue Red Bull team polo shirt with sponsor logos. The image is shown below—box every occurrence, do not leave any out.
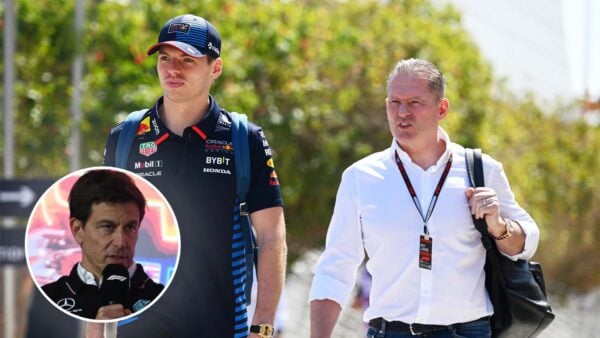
[104,97,283,337]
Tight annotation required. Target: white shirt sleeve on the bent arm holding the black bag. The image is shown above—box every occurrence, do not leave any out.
[483,154,540,260]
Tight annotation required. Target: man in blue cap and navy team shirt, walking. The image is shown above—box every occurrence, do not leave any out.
[98,15,287,338]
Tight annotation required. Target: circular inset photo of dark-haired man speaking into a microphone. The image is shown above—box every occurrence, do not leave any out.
[25,167,180,323]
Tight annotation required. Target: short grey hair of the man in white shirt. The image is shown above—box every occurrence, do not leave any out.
[387,59,446,99]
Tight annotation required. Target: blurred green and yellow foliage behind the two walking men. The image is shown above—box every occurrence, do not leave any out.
[0,0,600,291]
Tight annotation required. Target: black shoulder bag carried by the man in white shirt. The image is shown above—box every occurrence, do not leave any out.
[465,149,554,337]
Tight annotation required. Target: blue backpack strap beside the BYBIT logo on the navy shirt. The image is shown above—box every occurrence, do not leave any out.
[231,112,258,305]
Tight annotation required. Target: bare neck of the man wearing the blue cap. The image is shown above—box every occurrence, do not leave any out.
[158,97,209,136]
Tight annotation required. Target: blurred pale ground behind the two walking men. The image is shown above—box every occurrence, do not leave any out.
[284,251,600,338]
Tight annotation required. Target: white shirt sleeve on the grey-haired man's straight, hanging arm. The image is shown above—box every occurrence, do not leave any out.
[309,168,365,306]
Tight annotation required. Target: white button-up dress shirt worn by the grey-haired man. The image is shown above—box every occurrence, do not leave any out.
[309,128,539,325]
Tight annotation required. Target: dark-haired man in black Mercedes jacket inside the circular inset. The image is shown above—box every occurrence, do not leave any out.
[42,169,164,319]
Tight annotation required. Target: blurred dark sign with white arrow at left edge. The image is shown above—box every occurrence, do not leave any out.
[0,179,54,217]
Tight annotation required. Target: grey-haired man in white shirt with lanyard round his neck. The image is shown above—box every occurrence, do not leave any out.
[309,59,539,338]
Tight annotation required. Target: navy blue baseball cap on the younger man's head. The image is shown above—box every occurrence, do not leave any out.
[147,14,221,58]
